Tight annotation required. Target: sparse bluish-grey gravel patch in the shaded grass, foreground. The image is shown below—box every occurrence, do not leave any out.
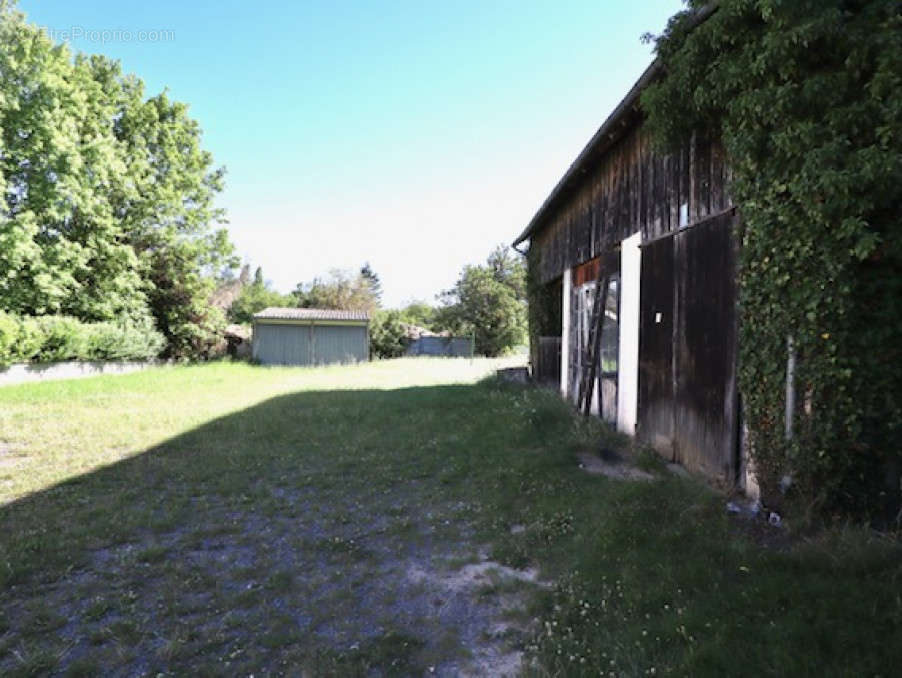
[0,491,546,676]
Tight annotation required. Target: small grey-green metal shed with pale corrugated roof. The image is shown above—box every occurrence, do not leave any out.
[253,308,370,365]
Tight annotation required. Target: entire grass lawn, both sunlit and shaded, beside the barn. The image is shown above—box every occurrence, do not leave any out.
[0,359,902,676]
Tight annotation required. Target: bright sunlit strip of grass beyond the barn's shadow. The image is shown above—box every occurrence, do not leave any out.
[0,357,523,504]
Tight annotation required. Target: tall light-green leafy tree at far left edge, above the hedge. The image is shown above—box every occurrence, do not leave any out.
[0,10,148,321]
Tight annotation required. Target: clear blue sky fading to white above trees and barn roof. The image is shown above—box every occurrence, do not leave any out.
[20,0,681,306]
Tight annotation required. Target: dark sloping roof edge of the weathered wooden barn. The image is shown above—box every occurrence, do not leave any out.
[512,2,717,248]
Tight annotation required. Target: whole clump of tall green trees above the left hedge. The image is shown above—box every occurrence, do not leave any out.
[0,2,235,357]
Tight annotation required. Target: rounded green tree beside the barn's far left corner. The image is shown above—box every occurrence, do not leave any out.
[435,246,526,356]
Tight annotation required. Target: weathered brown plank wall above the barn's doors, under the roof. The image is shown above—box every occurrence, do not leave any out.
[531,115,731,282]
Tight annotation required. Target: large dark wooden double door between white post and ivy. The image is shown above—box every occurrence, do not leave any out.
[639,213,738,483]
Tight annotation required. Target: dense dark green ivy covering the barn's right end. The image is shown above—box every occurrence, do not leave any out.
[642,0,902,518]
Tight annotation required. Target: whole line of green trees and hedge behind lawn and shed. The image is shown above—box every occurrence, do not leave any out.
[0,0,526,362]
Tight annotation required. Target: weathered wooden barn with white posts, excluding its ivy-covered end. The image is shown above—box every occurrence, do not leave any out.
[514,62,745,485]
